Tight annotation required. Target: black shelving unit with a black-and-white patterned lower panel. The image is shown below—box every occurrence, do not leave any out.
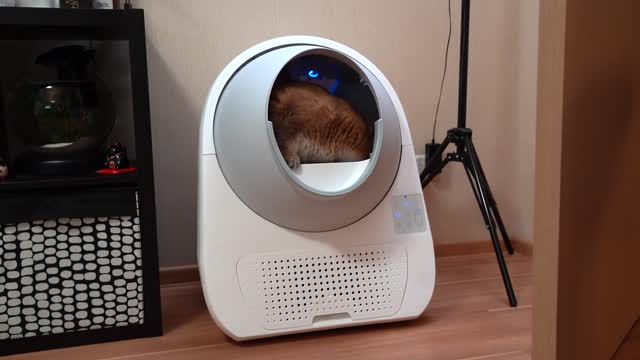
[0,8,162,355]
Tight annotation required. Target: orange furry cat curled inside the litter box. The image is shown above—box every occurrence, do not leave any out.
[269,83,373,169]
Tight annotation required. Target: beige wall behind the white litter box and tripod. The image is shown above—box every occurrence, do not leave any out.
[135,0,538,266]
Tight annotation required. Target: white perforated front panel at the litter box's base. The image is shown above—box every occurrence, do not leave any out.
[237,246,407,330]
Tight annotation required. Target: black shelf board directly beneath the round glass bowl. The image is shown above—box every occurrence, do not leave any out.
[0,174,138,193]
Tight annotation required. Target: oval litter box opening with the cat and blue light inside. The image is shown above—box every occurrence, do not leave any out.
[268,50,382,196]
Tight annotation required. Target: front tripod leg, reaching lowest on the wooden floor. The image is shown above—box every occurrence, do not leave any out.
[464,138,518,307]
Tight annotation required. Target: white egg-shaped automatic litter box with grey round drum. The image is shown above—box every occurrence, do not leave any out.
[198,36,435,340]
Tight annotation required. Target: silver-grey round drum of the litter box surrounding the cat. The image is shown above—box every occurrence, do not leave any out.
[211,45,402,232]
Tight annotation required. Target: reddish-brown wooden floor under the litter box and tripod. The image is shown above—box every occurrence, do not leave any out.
[6,254,532,360]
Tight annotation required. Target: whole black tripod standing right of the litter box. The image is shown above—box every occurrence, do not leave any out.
[420,0,518,306]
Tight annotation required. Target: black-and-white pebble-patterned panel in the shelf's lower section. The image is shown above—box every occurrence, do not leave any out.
[0,216,144,340]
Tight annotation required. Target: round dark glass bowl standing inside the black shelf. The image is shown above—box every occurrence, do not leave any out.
[8,45,115,176]
